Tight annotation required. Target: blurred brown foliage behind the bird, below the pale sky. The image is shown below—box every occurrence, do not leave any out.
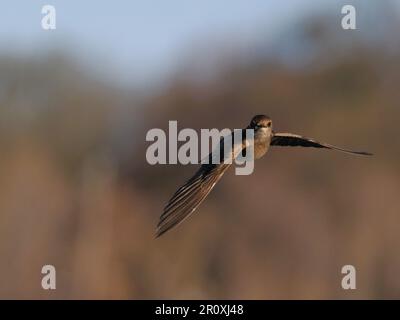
[0,13,400,299]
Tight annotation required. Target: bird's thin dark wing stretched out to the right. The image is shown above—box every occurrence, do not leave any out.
[271,133,372,156]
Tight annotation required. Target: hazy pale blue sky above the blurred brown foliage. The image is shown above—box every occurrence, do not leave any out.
[0,0,344,85]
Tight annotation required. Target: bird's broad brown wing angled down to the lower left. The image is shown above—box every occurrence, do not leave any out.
[156,132,246,237]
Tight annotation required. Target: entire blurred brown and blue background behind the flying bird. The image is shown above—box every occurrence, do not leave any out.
[0,0,400,299]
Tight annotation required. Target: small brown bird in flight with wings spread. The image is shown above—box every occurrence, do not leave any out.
[156,115,372,238]
